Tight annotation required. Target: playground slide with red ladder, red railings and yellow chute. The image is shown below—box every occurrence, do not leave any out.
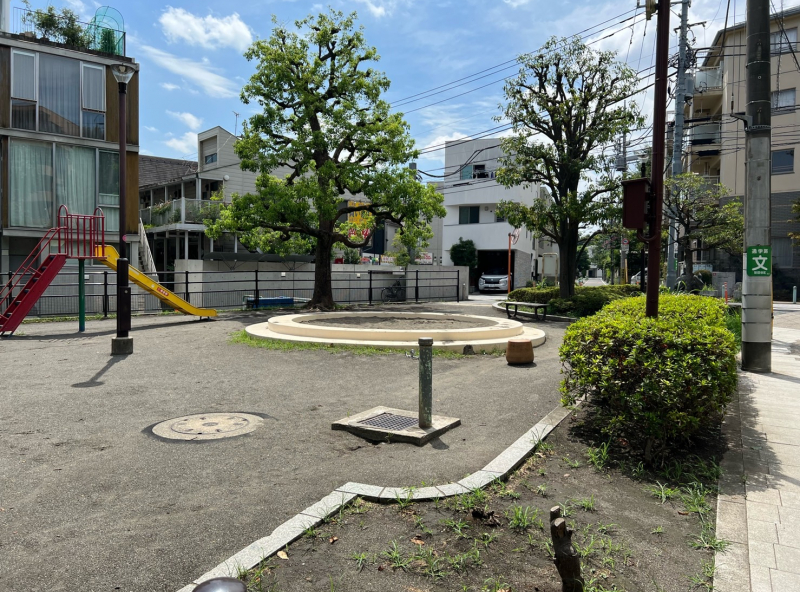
[0,205,217,335]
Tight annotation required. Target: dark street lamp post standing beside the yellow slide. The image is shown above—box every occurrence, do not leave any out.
[111,64,135,356]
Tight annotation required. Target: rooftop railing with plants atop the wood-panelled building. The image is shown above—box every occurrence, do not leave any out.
[12,6,126,56]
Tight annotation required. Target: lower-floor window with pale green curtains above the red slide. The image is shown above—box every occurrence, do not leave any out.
[8,138,119,232]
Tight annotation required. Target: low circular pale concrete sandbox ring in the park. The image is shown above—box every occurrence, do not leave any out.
[247,312,545,353]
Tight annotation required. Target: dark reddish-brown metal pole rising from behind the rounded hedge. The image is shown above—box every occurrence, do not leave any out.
[645,2,669,317]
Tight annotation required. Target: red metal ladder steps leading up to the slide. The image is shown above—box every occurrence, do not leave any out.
[0,228,67,335]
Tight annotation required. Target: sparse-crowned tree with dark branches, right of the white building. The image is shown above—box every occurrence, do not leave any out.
[497,38,642,298]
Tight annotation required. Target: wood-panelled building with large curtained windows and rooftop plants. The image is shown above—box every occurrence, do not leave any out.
[0,3,139,274]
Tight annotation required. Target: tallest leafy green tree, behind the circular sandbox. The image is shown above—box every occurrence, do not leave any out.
[208,9,445,308]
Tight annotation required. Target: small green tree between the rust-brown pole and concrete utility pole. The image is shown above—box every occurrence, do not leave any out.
[664,173,744,278]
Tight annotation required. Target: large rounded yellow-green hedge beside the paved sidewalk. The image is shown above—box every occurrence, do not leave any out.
[559,295,737,460]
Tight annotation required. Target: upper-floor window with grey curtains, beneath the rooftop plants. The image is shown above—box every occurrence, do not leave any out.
[11,50,106,140]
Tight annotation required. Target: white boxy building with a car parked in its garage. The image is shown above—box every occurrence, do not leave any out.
[434,138,555,288]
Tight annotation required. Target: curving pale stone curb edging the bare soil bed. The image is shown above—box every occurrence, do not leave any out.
[177,405,571,592]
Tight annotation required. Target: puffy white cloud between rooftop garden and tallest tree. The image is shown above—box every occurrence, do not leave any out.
[158,6,253,52]
